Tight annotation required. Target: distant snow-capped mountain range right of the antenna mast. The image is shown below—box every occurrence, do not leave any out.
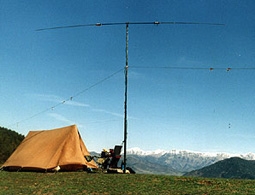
[124,148,255,175]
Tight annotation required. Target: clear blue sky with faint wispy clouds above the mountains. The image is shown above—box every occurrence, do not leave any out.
[0,0,255,153]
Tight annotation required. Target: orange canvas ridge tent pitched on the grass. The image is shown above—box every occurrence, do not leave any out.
[2,125,97,171]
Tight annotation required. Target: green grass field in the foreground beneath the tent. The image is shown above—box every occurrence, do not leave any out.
[0,171,255,195]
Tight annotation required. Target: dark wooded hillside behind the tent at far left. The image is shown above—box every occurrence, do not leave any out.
[0,127,25,164]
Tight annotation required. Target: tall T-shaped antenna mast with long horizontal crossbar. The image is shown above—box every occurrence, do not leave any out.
[36,21,224,173]
